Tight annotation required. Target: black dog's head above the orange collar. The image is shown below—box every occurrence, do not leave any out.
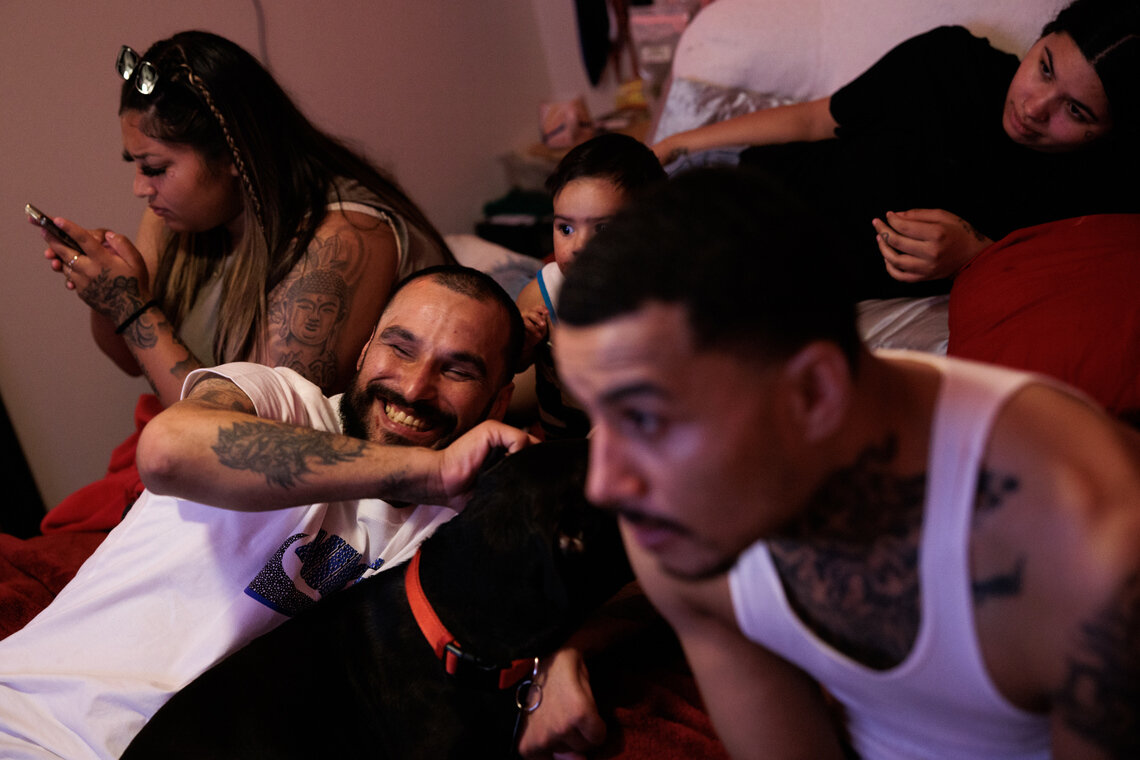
[421,441,633,656]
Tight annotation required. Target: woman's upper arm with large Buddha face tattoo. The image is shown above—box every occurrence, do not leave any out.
[263,212,399,393]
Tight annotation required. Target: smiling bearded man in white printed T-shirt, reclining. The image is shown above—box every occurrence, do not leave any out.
[0,267,528,759]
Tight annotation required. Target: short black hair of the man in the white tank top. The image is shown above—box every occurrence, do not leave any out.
[559,166,861,367]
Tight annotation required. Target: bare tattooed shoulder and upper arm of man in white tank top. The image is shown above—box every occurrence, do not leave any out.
[971,384,1140,746]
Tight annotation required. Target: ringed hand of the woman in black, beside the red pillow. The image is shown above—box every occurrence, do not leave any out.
[871,209,993,283]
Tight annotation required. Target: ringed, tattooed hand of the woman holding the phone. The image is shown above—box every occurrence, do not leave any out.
[44,219,150,325]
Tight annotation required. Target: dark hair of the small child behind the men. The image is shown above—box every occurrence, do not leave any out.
[546,132,666,197]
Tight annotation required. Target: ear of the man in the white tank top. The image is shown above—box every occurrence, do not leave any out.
[780,341,853,443]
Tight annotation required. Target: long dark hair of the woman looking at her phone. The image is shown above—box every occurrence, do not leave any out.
[119,31,447,360]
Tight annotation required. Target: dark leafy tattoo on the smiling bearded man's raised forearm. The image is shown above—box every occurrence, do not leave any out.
[213,422,365,489]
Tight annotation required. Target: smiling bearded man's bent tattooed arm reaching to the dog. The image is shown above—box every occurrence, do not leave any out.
[138,377,528,512]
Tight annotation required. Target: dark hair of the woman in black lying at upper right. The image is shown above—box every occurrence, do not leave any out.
[1041,0,1140,134]
